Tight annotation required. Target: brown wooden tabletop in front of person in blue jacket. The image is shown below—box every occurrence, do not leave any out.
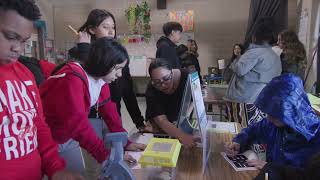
[133,124,258,180]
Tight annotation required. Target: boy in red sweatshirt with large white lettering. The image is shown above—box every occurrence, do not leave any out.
[0,0,81,180]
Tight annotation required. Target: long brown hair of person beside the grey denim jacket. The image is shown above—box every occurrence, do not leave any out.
[279,30,306,63]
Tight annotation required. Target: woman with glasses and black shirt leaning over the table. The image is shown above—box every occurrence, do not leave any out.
[146,59,195,147]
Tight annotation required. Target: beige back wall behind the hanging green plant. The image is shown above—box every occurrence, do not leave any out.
[40,0,296,74]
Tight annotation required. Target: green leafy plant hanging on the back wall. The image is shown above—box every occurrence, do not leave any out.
[125,1,151,40]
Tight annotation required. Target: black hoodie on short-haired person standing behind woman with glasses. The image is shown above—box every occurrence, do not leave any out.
[156,36,181,69]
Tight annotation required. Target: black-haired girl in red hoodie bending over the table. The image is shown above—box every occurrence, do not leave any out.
[40,38,142,174]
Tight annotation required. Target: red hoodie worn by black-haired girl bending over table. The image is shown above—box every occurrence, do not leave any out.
[40,63,129,162]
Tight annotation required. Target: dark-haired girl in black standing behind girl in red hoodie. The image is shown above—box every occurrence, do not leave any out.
[69,9,151,132]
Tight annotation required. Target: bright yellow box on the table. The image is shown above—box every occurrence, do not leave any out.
[139,138,181,167]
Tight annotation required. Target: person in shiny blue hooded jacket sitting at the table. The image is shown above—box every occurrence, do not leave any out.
[226,74,320,169]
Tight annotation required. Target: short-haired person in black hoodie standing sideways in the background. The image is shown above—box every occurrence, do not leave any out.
[156,22,183,68]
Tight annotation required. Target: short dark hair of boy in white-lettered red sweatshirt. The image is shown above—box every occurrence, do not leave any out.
[0,0,41,21]
